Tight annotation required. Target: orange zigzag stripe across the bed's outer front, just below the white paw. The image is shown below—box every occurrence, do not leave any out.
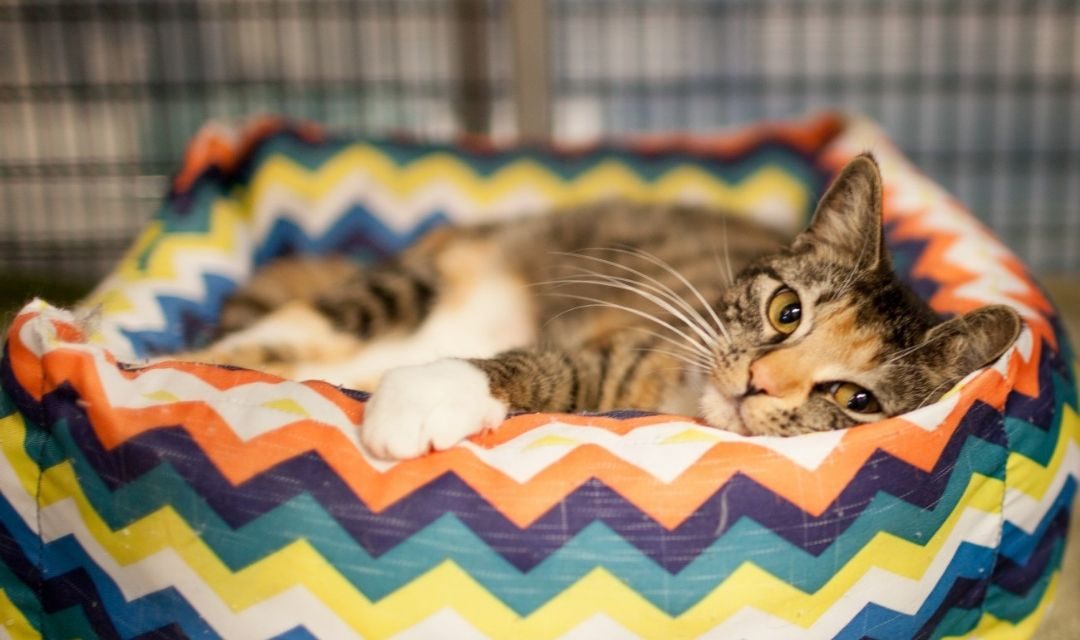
[4,312,1031,528]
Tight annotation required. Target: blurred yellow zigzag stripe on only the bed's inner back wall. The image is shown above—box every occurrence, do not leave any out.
[238,145,811,220]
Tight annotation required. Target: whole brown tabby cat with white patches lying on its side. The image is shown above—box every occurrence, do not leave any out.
[188,154,1021,459]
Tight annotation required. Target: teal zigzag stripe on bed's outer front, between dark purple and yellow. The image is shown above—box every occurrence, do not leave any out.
[38,405,1000,613]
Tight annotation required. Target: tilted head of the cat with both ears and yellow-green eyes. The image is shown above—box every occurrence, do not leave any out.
[701,155,1021,435]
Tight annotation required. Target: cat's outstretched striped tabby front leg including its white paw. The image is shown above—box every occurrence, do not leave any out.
[361,333,680,459]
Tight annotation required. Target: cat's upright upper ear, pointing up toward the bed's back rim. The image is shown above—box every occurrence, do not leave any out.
[794,153,888,269]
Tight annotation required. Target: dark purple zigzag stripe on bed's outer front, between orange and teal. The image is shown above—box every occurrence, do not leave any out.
[33,362,1003,571]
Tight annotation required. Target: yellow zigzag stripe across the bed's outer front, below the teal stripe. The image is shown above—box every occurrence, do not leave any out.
[3,397,1002,638]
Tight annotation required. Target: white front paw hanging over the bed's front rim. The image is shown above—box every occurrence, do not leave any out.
[360,358,507,460]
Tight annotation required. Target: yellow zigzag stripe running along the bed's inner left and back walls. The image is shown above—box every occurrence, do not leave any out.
[85,145,811,341]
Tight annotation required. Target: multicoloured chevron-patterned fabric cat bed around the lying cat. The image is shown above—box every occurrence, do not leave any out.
[0,115,1080,640]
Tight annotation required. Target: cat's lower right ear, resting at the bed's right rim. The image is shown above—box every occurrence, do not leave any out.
[923,304,1022,380]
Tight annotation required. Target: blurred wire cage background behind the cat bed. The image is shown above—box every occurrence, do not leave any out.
[0,0,1080,638]
